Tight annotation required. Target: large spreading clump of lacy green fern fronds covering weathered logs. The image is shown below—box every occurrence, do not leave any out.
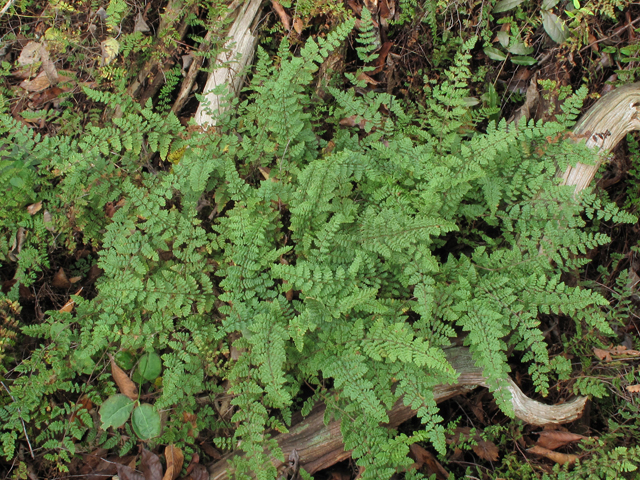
[0,13,635,479]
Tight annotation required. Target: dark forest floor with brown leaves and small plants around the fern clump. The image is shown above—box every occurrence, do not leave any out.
[0,0,640,480]
